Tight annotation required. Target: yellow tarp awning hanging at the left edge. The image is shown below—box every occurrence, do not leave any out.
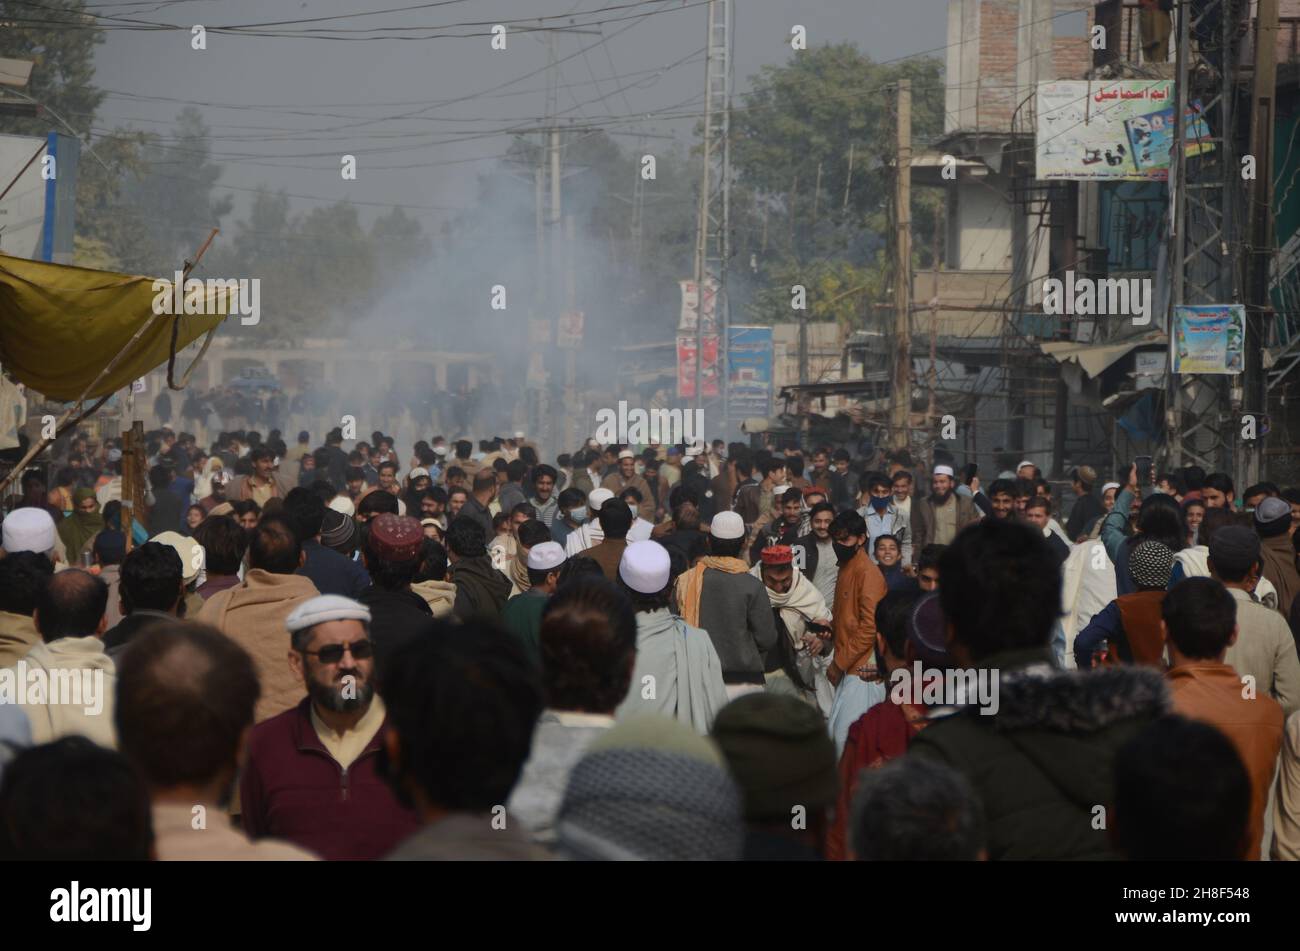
[0,253,226,400]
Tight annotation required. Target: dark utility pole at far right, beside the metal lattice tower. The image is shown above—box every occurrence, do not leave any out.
[1235,0,1278,486]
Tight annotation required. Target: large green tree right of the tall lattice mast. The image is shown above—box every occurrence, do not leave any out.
[731,44,943,335]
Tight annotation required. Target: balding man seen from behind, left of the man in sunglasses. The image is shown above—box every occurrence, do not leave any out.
[113,621,315,861]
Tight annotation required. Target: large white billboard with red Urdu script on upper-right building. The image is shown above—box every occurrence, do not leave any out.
[1035,79,1213,182]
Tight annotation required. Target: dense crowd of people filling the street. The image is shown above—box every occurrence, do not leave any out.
[0,429,1300,860]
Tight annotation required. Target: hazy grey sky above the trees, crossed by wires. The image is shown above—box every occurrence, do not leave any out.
[95,0,948,226]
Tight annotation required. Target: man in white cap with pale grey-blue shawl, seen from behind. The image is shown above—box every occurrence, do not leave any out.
[614,537,728,734]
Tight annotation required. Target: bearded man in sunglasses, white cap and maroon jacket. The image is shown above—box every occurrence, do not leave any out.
[239,595,419,861]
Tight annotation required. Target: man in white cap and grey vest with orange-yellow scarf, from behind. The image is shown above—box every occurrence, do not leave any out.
[677,512,776,698]
